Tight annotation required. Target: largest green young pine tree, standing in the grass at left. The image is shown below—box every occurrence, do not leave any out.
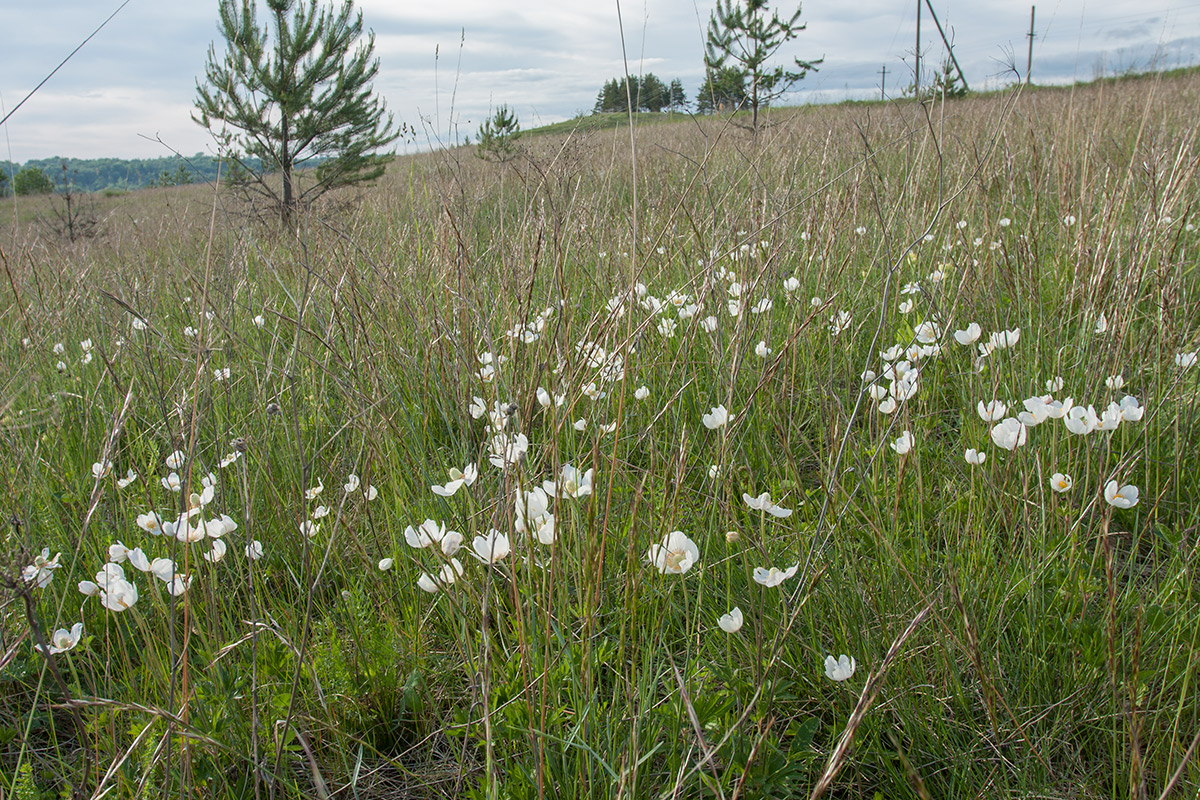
[192,0,404,225]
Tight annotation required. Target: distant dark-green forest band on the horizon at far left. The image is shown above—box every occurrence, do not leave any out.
[0,152,261,192]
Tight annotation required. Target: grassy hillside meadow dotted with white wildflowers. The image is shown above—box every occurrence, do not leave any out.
[0,71,1200,800]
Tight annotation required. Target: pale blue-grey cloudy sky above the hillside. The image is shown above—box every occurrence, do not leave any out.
[0,0,1200,162]
